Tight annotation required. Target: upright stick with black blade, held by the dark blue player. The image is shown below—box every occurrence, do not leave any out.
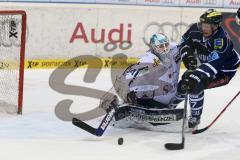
[165,94,188,150]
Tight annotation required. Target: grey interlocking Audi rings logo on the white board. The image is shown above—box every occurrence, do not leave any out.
[143,22,189,45]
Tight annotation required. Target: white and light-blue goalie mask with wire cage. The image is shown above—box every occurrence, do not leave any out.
[149,33,170,65]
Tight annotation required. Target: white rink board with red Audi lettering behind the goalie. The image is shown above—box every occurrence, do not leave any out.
[0,4,236,59]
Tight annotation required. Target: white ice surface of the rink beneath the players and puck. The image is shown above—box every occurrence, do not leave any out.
[0,69,240,160]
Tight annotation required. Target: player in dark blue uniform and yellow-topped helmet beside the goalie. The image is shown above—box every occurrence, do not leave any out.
[172,9,240,128]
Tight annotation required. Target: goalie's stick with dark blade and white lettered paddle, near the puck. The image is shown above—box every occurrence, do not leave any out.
[72,108,115,137]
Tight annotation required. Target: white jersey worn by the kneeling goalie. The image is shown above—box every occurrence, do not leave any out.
[117,43,181,105]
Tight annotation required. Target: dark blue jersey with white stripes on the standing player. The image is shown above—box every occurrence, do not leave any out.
[180,23,240,77]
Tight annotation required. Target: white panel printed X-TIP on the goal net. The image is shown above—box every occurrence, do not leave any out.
[0,18,22,47]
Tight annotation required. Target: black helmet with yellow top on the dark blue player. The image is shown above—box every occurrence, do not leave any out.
[200,9,222,25]
